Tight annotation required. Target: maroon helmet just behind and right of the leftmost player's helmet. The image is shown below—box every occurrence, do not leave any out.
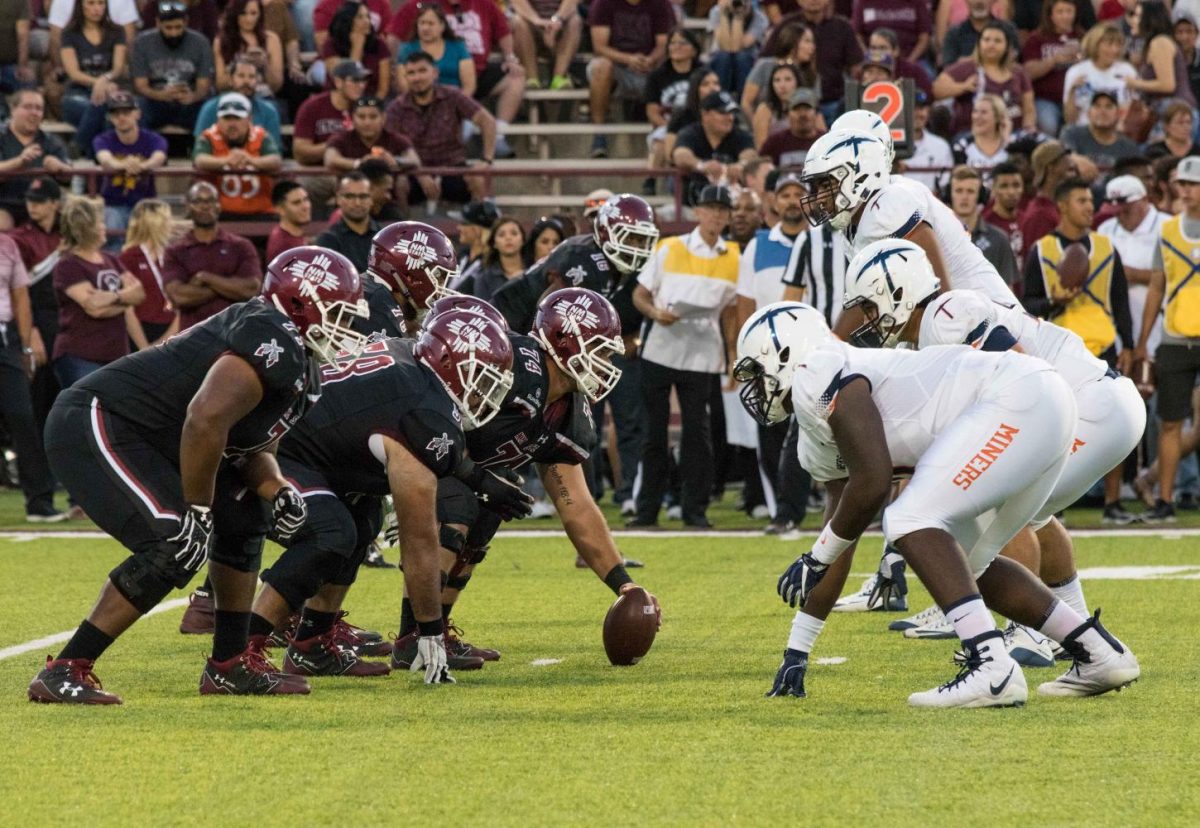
[367,221,458,314]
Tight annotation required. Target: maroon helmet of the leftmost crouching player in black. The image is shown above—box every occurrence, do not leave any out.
[262,246,370,362]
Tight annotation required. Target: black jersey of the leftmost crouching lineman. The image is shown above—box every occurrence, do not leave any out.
[74,298,320,463]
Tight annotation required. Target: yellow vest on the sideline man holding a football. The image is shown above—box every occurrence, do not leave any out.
[1038,233,1117,356]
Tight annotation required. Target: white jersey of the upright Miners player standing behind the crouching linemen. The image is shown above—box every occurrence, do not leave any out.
[847,175,1016,305]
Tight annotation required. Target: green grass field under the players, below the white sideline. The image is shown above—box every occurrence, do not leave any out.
[0,525,1200,826]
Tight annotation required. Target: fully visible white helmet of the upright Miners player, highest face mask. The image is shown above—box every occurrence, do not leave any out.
[800,130,892,230]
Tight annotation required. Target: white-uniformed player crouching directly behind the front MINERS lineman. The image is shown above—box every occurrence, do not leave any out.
[846,239,1146,666]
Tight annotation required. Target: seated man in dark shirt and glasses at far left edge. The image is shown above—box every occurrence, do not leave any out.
[0,89,71,230]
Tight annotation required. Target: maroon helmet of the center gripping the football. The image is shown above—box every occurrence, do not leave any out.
[533,288,625,402]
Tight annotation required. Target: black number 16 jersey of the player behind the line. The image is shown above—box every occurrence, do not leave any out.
[492,235,642,334]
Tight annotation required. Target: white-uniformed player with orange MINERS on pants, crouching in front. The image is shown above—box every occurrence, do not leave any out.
[736,302,1140,708]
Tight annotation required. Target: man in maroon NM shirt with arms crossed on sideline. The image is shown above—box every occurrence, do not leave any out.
[162,181,263,330]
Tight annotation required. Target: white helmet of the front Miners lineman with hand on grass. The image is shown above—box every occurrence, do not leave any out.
[733,302,834,426]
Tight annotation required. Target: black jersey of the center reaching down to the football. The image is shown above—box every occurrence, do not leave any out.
[467,334,596,469]
